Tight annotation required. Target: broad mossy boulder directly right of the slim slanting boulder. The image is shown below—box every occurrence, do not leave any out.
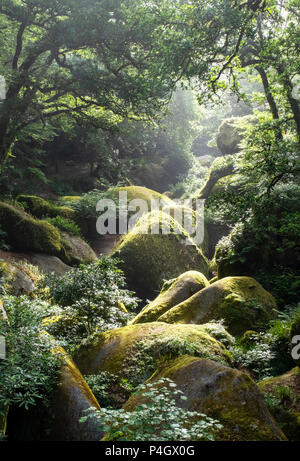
[158,277,276,336]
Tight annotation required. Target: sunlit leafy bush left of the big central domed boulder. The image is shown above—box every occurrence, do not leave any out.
[40,258,138,344]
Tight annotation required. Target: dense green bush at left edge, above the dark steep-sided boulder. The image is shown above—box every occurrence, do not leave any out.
[0,296,60,414]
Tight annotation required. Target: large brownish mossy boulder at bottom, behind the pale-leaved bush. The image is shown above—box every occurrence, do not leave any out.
[123,356,286,441]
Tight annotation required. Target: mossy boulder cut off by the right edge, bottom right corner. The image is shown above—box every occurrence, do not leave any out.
[258,367,300,442]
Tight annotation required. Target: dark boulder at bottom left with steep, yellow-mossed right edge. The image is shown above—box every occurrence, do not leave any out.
[8,348,103,442]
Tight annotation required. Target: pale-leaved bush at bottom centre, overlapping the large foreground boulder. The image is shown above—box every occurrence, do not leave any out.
[80,379,222,441]
